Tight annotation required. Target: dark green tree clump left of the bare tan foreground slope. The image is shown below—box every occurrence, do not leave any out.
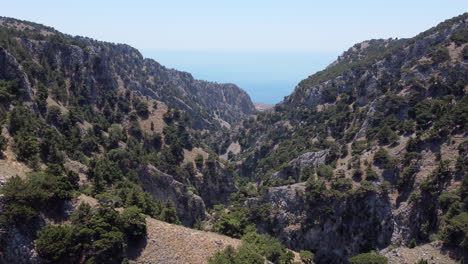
[36,202,146,264]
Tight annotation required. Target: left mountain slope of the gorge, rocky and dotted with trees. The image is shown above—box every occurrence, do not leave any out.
[0,17,255,263]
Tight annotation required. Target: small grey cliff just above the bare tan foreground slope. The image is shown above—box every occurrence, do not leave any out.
[139,166,206,226]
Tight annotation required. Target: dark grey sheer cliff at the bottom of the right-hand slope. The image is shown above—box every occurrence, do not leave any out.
[251,183,394,263]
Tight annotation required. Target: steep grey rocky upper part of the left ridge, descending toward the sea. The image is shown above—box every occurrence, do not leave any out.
[0,18,255,129]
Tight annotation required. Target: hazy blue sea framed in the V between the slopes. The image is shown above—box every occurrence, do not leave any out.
[142,50,339,104]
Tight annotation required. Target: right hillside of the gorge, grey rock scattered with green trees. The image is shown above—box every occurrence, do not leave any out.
[218,14,468,263]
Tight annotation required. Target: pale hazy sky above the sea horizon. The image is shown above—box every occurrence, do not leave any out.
[0,0,468,52]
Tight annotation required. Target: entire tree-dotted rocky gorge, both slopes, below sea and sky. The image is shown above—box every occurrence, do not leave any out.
[0,13,468,264]
